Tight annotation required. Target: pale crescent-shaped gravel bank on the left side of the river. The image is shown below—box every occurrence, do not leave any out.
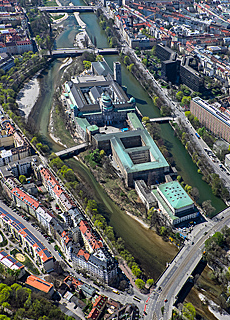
[16,71,40,119]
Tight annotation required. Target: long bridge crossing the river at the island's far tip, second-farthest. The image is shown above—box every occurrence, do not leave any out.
[52,48,118,58]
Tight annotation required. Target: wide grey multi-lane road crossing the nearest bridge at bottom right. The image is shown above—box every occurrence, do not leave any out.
[144,208,230,320]
